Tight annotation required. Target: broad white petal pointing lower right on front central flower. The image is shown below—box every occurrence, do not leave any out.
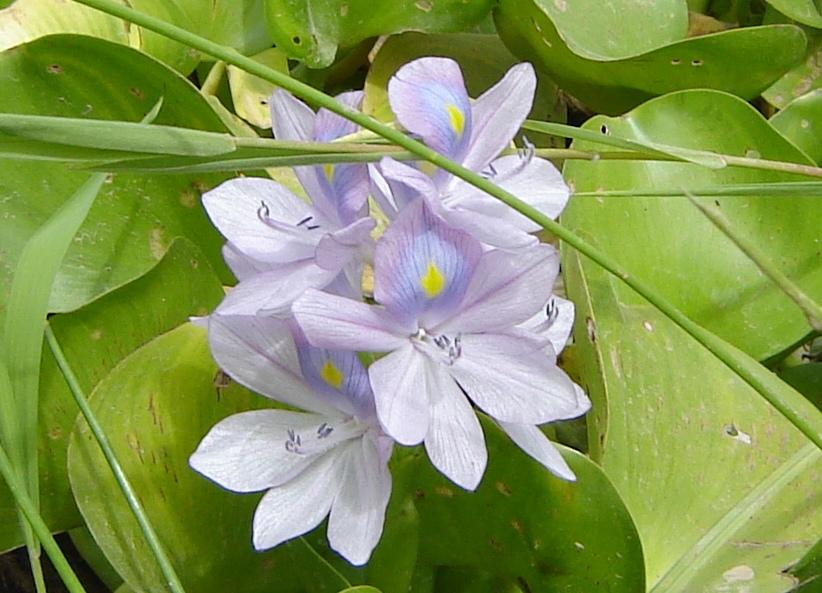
[448,334,581,424]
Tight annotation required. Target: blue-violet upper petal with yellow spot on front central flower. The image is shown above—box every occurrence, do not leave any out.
[374,200,482,325]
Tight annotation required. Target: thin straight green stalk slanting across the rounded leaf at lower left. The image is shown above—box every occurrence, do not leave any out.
[45,322,185,593]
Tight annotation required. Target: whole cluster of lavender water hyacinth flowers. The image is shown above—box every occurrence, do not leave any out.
[190,58,590,565]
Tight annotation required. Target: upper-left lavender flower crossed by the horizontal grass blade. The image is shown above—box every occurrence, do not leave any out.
[203,90,375,315]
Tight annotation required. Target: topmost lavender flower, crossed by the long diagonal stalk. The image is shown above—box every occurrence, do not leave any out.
[370,57,569,249]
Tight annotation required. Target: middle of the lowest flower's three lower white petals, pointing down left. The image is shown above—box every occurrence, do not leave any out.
[249,448,345,550]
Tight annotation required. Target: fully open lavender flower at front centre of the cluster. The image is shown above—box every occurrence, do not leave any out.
[292,200,590,489]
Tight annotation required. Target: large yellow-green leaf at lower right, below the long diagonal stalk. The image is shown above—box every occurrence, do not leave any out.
[563,244,822,593]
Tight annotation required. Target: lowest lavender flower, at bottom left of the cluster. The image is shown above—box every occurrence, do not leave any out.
[190,315,392,565]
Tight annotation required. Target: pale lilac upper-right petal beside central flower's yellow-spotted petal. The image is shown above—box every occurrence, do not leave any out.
[435,244,559,333]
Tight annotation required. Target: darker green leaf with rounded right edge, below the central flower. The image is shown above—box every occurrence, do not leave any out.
[393,422,645,593]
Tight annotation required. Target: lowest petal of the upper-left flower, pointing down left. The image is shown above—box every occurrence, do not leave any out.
[217,259,339,317]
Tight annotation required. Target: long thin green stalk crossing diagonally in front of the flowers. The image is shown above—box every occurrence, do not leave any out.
[69,0,822,448]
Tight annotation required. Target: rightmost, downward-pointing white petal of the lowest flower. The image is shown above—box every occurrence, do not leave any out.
[328,437,391,566]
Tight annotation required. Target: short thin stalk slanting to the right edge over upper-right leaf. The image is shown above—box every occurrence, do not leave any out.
[687,194,822,331]
